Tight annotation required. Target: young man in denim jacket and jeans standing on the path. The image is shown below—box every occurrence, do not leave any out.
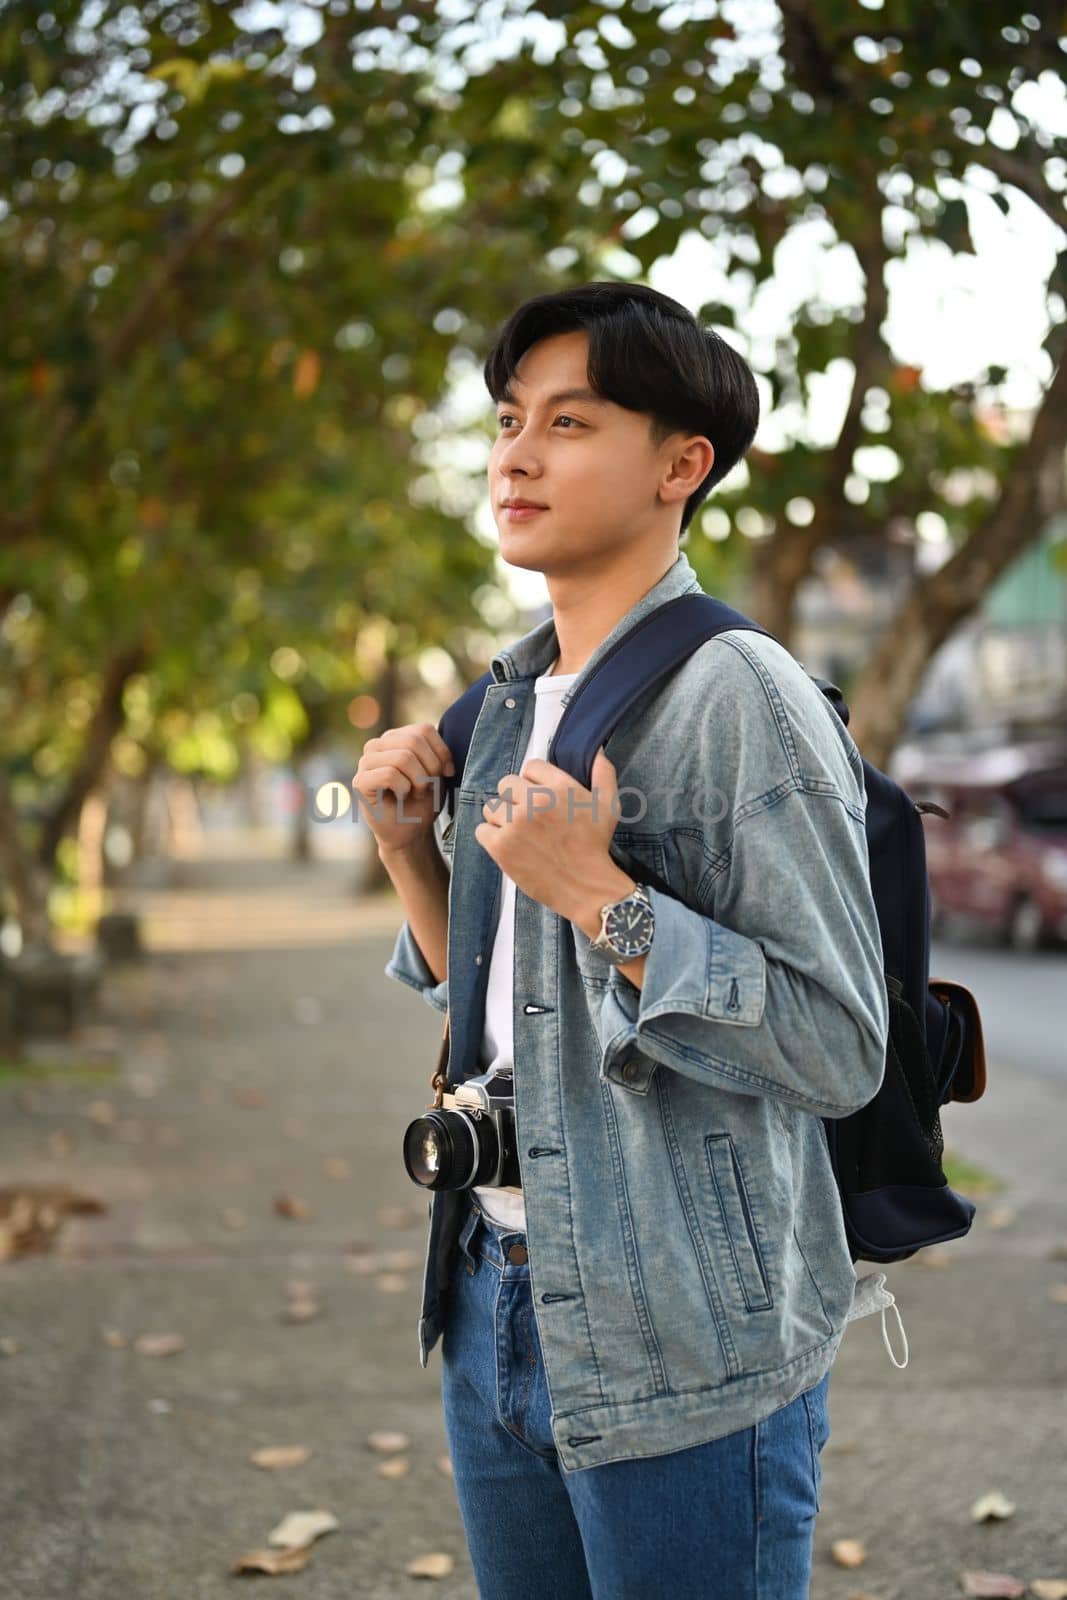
[355,283,888,1600]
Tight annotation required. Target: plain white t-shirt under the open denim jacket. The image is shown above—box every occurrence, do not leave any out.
[474,661,577,1232]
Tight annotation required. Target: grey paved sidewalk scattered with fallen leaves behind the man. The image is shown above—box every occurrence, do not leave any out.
[0,846,1067,1600]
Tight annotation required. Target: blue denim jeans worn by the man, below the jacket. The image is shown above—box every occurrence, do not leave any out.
[442,1197,830,1600]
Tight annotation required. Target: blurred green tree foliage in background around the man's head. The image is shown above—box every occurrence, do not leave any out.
[0,0,1067,928]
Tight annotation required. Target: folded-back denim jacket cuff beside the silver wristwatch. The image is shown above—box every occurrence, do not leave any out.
[600,885,766,1094]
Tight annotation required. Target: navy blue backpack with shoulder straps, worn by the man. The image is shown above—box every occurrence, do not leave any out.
[438,594,985,1262]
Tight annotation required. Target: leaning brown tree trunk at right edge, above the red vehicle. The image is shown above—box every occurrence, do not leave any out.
[849,360,1067,766]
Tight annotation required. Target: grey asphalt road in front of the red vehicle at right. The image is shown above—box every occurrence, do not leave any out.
[929,939,1067,1083]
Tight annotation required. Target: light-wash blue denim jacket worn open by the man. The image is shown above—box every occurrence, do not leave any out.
[386,552,888,1472]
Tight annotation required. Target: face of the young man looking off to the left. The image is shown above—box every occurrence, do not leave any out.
[488,330,685,576]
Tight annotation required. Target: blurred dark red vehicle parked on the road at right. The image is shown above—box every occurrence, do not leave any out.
[893,744,1067,950]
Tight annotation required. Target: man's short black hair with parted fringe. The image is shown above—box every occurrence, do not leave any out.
[485,283,760,533]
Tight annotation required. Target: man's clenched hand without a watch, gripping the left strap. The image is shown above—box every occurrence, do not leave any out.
[352,722,456,853]
